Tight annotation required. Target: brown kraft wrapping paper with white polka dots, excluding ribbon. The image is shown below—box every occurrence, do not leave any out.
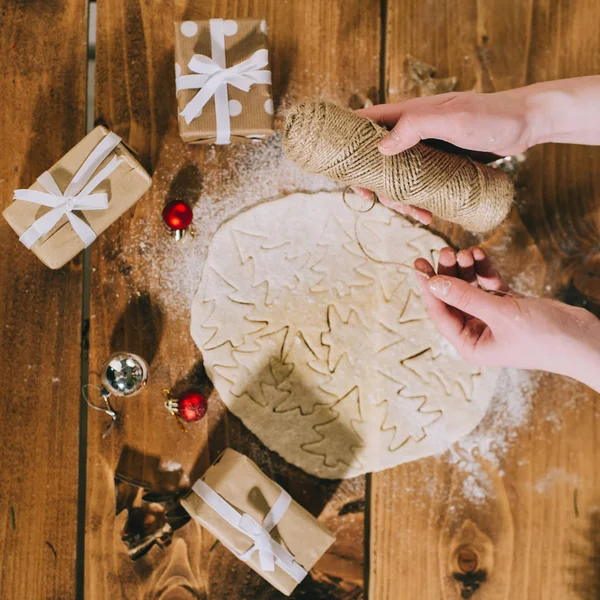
[174,19,273,144]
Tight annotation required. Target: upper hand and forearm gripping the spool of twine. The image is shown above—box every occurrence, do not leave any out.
[355,75,600,225]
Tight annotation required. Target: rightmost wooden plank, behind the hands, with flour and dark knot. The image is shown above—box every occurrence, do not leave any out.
[369,0,600,600]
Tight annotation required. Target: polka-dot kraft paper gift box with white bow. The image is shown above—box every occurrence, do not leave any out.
[175,19,273,144]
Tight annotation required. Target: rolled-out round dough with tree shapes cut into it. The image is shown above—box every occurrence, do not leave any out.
[192,192,498,479]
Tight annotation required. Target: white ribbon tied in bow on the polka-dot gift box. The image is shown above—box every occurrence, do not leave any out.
[175,19,271,144]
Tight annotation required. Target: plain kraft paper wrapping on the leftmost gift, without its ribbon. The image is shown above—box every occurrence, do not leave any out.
[3,126,151,269]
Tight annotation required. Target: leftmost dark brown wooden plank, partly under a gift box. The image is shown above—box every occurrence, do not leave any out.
[0,0,87,600]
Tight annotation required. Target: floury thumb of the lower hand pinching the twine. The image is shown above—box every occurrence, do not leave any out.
[428,275,506,324]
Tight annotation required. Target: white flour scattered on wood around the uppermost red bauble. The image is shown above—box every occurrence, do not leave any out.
[114,133,340,318]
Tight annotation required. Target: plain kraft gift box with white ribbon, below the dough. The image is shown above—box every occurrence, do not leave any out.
[181,449,335,595]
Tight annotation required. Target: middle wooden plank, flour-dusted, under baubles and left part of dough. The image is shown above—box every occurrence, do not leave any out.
[86,0,380,600]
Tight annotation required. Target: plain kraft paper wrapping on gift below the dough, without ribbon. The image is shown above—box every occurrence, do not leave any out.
[181,448,335,595]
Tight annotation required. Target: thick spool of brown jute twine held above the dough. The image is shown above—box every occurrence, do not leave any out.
[283,102,514,232]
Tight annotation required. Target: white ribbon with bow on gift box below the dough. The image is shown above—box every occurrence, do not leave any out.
[192,479,307,583]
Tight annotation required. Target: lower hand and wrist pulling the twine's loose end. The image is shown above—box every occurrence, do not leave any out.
[415,247,600,391]
